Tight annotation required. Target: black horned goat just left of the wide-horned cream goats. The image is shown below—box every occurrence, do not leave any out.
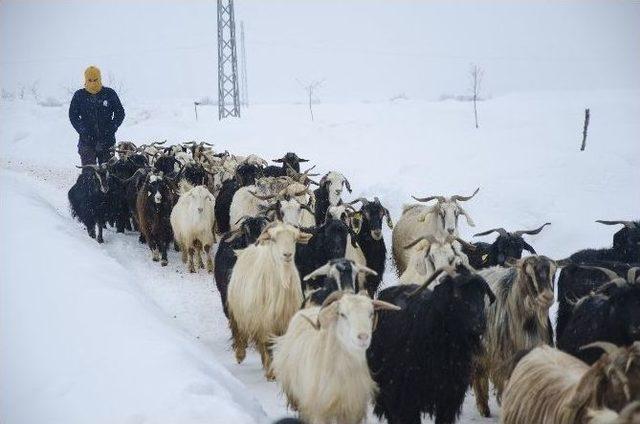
[351,197,393,297]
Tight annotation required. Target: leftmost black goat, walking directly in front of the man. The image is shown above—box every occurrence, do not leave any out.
[67,163,110,243]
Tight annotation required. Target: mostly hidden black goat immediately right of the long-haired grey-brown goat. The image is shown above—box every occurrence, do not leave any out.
[556,261,640,339]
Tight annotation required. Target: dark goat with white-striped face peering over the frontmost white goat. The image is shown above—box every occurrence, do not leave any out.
[302,258,376,308]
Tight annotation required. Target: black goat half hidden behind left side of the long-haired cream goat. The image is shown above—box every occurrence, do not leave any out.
[213,216,269,318]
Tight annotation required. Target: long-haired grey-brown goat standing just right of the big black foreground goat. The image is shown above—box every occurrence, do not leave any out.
[473,256,556,417]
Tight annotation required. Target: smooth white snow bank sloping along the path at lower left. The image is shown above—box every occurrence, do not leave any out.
[0,171,264,424]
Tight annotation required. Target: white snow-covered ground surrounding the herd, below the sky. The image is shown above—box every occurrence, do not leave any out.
[0,91,640,424]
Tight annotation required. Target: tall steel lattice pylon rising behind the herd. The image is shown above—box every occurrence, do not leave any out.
[218,0,240,119]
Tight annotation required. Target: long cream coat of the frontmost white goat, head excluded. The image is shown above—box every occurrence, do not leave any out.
[273,296,376,424]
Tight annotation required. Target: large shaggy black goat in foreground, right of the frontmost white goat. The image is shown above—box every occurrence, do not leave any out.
[367,266,495,424]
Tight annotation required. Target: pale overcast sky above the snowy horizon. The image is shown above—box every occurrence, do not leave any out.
[0,0,640,103]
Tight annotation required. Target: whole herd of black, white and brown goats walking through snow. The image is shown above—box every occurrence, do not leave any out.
[69,142,640,424]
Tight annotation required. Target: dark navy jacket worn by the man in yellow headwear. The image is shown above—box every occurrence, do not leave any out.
[69,87,124,151]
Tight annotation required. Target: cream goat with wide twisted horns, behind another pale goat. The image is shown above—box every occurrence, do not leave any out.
[391,188,480,276]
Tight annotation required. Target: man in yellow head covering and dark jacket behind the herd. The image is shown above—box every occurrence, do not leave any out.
[69,66,124,165]
